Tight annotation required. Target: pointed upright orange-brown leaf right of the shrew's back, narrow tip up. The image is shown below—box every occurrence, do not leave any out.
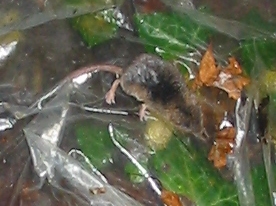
[198,46,219,86]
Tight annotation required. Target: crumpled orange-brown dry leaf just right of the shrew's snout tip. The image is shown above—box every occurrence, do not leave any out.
[208,127,236,168]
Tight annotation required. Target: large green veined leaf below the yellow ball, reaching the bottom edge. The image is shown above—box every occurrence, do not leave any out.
[151,138,239,206]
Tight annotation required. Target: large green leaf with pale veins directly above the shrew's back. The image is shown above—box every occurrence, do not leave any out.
[134,13,212,69]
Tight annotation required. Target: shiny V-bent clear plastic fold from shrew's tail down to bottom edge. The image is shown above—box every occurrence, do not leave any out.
[24,69,143,206]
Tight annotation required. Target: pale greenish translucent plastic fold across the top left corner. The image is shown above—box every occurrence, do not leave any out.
[0,0,122,35]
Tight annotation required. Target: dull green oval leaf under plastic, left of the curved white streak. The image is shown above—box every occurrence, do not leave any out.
[74,123,114,169]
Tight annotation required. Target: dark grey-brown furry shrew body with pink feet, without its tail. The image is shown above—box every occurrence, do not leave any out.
[106,54,205,139]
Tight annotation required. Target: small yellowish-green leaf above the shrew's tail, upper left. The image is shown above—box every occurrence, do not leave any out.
[70,9,118,47]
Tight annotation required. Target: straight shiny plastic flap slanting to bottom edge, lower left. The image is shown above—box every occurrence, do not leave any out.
[25,130,141,206]
